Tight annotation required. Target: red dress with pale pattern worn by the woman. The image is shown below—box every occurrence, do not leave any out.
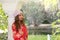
[12,24,28,40]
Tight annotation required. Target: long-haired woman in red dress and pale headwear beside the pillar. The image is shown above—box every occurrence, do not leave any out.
[12,11,28,40]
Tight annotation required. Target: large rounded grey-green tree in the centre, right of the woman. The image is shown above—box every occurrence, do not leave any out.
[22,1,45,26]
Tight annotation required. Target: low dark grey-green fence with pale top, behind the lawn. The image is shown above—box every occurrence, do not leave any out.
[28,24,55,34]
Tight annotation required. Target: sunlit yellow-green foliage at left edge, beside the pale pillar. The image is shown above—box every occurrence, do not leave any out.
[0,3,8,30]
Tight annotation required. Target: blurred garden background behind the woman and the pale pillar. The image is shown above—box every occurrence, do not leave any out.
[0,0,60,40]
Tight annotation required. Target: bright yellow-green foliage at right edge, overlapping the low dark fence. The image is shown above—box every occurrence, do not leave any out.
[51,11,60,35]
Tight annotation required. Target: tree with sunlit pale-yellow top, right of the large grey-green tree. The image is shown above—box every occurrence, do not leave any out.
[43,0,58,23]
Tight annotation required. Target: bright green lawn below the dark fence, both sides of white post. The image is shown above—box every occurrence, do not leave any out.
[28,35,60,40]
